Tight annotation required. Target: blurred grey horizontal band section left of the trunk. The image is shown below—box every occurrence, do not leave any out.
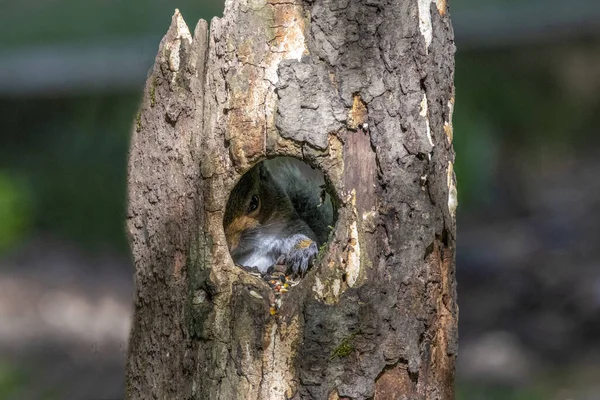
[0,37,160,97]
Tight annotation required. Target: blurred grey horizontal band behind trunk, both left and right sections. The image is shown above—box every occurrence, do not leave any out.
[0,0,600,97]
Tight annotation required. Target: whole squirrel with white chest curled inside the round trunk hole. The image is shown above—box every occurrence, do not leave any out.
[223,157,333,276]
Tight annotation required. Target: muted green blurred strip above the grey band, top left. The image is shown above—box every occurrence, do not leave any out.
[0,0,223,48]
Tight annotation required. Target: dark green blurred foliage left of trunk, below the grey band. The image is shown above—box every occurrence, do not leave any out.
[0,93,141,250]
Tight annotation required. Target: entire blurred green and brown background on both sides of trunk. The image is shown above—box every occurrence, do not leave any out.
[0,0,600,400]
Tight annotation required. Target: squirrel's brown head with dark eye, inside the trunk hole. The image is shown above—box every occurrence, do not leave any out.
[223,162,294,252]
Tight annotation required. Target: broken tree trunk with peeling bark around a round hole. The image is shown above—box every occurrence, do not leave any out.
[127,0,458,400]
